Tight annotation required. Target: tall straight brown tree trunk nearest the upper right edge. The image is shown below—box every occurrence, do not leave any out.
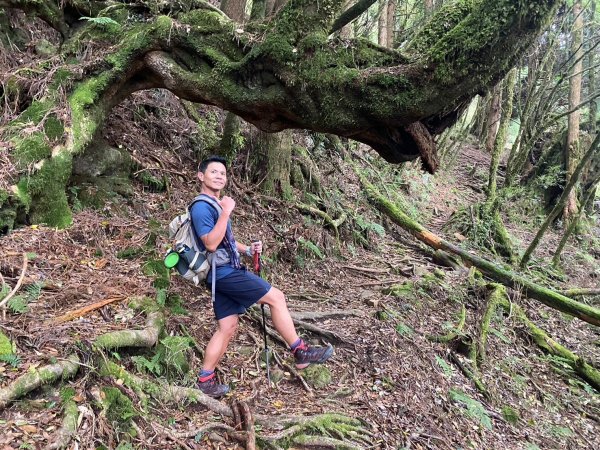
[563,0,583,223]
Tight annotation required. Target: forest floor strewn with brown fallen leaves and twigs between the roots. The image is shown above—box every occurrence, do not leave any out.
[0,118,600,449]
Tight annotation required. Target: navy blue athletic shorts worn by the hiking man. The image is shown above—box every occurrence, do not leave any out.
[208,269,271,320]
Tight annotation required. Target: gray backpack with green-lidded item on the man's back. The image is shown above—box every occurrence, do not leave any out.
[164,194,229,288]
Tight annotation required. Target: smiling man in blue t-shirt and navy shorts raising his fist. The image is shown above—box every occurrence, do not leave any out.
[191,156,333,397]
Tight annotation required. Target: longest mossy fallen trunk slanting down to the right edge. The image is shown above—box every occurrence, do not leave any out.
[355,167,600,326]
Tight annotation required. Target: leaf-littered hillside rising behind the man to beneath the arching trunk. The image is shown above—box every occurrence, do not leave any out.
[0,91,600,449]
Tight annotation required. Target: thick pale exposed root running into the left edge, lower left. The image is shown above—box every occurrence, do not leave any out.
[0,355,80,411]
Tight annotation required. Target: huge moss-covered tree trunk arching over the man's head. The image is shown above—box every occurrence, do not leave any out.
[0,0,559,226]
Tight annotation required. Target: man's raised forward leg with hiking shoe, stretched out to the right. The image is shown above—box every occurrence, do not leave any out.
[258,287,333,369]
